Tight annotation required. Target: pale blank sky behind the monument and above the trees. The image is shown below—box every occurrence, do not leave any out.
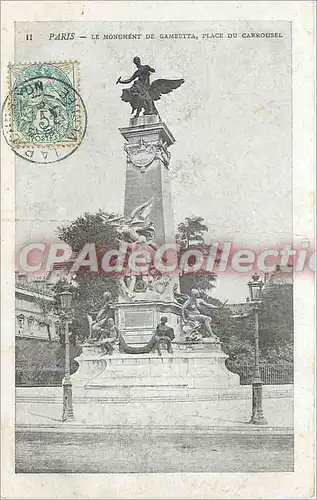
[15,22,292,302]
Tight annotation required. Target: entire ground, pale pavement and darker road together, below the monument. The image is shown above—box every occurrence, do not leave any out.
[16,386,293,473]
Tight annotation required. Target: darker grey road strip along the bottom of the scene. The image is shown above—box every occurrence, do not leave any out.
[16,430,293,473]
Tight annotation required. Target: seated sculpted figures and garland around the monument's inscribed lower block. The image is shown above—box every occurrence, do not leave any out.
[86,288,219,356]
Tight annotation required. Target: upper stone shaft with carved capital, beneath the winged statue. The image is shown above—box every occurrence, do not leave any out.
[120,115,175,245]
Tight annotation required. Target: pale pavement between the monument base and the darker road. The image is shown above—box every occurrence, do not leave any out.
[16,386,293,430]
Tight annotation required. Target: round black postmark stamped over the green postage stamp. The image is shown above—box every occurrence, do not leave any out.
[2,75,87,163]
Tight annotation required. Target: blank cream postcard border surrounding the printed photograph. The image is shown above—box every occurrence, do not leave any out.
[1,1,315,499]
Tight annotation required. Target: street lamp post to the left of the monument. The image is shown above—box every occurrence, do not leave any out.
[60,285,75,422]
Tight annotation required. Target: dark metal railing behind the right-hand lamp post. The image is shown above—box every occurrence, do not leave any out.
[226,360,294,385]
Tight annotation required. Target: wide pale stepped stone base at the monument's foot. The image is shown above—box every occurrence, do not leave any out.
[72,341,239,402]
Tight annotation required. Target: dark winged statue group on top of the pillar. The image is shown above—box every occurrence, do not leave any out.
[116,57,185,117]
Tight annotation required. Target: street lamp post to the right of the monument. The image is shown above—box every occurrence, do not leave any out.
[248,274,267,425]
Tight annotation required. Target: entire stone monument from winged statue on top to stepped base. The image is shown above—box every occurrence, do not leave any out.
[72,57,239,401]
